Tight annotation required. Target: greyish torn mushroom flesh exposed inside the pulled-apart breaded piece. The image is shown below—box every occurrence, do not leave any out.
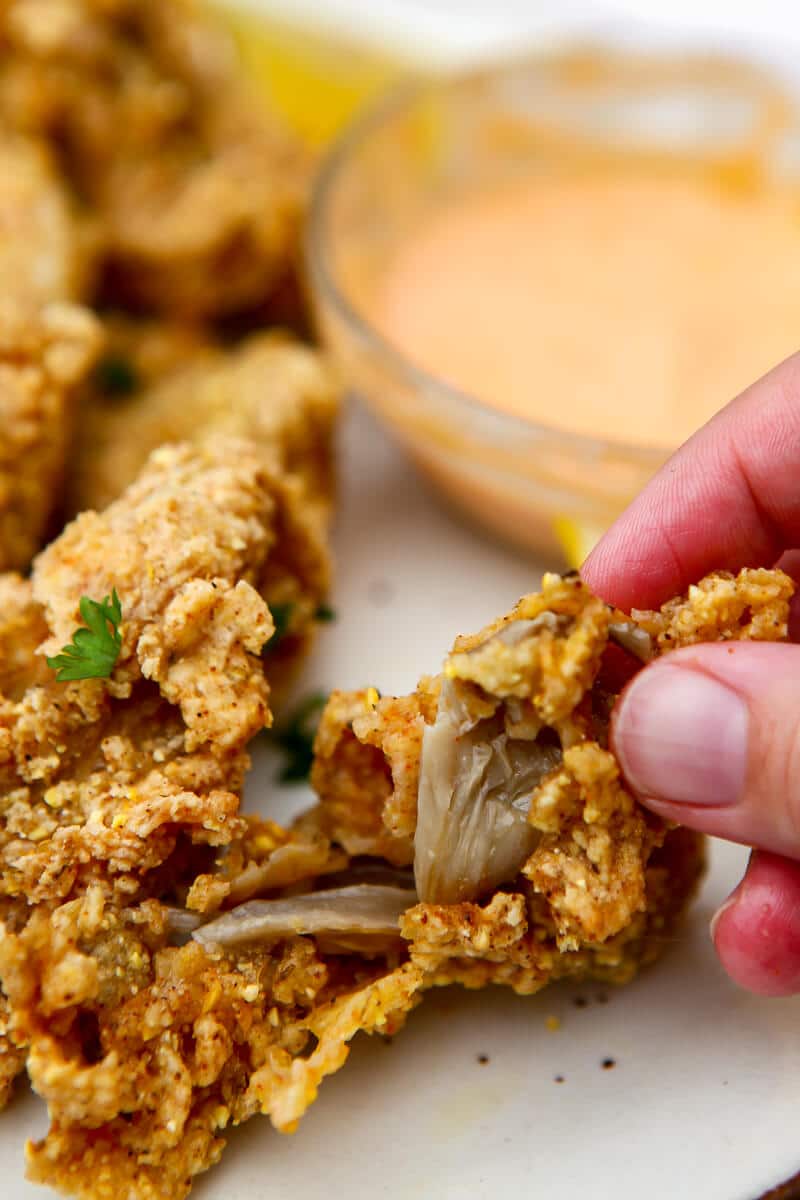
[181,576,652,949]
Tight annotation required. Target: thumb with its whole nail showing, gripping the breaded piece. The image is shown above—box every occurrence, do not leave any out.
[612,642,800,859]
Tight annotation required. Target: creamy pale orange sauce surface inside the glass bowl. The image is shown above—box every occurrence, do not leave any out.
[372,166,800,449]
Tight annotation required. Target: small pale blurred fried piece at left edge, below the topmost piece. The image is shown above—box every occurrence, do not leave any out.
[0,138,90,310]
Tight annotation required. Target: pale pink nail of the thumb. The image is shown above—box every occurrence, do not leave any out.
[614,664,748,805]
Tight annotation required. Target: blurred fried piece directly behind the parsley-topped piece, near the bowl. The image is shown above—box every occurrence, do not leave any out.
[67,323,338,694]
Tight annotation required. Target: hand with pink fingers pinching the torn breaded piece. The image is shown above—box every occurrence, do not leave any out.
[582,354,800,996]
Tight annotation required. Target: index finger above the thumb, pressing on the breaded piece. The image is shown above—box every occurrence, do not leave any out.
[581,354,800,610]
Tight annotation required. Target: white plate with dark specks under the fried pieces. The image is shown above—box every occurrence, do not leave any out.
[0,413,800,1200]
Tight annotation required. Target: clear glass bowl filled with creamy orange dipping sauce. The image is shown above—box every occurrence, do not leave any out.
[308,47,800,566]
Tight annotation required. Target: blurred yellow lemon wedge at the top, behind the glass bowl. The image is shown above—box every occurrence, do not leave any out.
[211,0,404,146]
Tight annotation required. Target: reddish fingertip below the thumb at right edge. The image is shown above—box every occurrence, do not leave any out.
[711,851,800,996]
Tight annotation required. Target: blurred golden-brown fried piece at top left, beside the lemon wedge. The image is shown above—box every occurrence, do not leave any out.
[0,0,308,316]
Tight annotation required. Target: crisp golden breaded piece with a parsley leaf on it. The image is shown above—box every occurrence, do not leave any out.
[0,442,284,902]
